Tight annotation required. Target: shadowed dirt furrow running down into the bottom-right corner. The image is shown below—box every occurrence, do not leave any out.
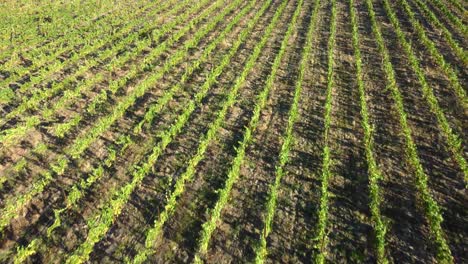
[376,0,468,259]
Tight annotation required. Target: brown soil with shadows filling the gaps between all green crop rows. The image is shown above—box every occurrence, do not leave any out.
[0,0,468,263]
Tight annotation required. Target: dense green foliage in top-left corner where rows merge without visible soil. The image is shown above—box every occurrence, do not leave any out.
[0,1,131,60]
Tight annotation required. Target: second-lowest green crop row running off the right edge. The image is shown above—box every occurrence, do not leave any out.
[398,0,468,107]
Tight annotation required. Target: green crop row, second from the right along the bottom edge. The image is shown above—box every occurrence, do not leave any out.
[349,0,388,264]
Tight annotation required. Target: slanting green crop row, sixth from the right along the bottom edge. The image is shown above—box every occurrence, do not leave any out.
[134,1,286,263]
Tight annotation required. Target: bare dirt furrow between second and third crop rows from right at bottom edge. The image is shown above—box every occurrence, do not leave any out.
[320,1,376,263]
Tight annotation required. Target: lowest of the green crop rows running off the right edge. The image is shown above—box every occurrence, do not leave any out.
[384,0,468,187]
